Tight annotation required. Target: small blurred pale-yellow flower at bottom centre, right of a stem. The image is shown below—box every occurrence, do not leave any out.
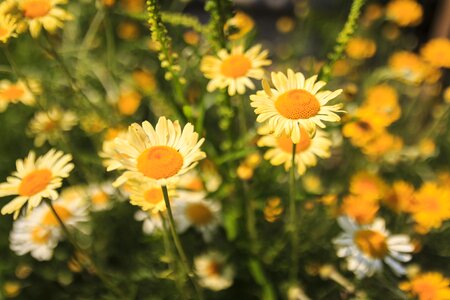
[194,251,234,291]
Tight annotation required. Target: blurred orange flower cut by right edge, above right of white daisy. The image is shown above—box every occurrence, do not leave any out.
[411,182,450,233]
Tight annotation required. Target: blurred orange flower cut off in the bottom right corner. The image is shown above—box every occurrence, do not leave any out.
[399,272,450,300]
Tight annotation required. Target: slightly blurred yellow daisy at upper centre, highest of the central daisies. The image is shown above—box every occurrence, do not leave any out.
[200,45,272,96]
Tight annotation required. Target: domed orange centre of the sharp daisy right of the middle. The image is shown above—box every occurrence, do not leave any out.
[275,89,320,120]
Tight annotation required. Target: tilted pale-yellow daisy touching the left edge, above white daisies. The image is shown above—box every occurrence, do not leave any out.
[0,149,74,219]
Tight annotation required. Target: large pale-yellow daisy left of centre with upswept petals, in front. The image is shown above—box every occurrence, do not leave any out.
[108,117,206,186]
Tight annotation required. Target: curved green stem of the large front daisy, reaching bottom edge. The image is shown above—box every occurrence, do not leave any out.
[161,185,203,299]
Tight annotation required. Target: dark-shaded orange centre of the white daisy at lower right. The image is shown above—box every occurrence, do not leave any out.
[354,230,388,258]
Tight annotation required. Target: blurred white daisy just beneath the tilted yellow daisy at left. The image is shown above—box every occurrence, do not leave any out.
[9,206,62,261]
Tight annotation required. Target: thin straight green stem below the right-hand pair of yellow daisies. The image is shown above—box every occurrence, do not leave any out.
[288,143,298,283]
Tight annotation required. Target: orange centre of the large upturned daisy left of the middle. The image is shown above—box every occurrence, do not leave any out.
[137,146,183,179]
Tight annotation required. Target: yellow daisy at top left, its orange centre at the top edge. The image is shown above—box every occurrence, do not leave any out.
[17,0,72,38]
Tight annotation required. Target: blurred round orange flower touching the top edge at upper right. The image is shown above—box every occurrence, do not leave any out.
[386,0,423,27]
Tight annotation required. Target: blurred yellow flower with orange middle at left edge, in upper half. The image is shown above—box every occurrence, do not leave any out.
[0,80,38,112]
